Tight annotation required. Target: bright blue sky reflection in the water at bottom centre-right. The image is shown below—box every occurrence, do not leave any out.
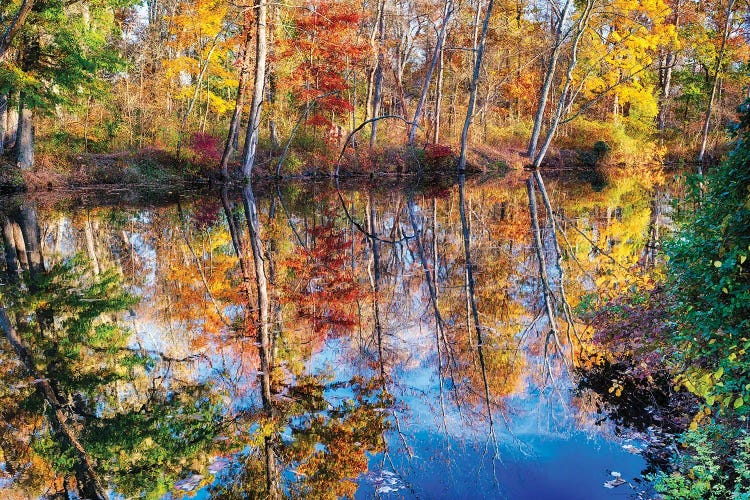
[309,316,645,500]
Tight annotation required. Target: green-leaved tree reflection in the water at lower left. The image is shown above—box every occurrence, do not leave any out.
[0,201,222,498]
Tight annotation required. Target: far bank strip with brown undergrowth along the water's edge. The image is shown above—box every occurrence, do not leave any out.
[0,141,668,193]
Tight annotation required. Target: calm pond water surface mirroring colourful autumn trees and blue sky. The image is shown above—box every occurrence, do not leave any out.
[0,170,680,498]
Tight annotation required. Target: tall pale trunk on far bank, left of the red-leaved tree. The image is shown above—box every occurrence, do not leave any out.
[242,0,268,180]
